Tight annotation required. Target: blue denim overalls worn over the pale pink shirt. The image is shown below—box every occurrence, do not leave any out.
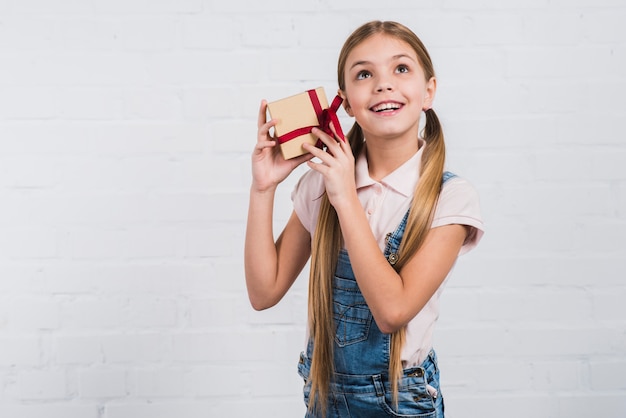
[298,172,454,418]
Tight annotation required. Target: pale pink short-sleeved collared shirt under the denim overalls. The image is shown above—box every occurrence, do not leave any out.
[292,141,484,367]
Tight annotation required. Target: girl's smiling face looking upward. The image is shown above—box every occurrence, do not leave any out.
[340,34,436,141]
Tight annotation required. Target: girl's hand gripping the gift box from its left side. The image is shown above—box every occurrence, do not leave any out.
[252,100,313,192]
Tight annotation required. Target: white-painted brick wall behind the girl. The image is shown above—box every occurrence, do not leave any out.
[0,0,626,418]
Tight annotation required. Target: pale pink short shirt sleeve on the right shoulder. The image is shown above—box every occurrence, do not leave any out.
[432,177,485,254]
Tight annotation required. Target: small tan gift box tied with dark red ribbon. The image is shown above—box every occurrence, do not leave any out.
[267,87,328,160]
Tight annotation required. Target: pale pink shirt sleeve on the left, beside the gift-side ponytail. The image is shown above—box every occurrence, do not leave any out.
[291,170,324,235]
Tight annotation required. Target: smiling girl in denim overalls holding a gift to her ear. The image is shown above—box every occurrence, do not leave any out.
[245,21,483,418]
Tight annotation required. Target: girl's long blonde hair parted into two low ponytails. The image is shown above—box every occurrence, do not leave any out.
[309,21,445,412]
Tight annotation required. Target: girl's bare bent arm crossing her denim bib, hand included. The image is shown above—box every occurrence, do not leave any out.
[306,131,467,333]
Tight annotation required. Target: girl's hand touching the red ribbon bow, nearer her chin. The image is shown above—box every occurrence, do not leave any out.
[303,125,356,210]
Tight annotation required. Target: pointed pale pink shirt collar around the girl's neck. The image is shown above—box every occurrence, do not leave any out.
[355,139,425,197]
